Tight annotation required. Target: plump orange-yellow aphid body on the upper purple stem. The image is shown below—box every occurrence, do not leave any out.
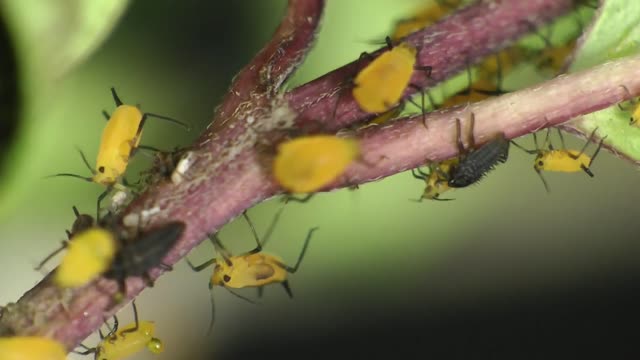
[353,43,417,113]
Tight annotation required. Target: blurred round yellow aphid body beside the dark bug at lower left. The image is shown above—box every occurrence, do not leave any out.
[53,227,117,288]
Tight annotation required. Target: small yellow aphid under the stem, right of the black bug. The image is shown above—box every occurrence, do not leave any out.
[511,128,607,191]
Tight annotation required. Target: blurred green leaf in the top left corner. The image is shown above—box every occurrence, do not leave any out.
[0,0,128,216]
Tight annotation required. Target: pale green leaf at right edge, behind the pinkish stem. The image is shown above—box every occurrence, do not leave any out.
[570,0,640,161]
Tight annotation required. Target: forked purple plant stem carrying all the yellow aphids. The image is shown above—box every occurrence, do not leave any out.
[0,0,640,349]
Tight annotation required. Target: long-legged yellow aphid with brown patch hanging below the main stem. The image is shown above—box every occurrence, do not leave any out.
[187,206,318,333]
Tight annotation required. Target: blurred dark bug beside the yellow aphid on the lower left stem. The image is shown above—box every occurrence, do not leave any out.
[104,221,186,294]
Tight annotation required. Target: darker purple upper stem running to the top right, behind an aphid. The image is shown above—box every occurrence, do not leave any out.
[287,0,573,131]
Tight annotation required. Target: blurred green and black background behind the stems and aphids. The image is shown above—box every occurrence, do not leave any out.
[0,0,640,360]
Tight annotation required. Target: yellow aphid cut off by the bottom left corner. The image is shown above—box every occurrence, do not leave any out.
[0,336,67,360]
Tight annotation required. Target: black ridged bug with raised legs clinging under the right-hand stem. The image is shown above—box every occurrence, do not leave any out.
[448,113,510,188]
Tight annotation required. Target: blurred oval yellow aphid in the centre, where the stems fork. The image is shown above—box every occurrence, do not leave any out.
[273,135,360,193]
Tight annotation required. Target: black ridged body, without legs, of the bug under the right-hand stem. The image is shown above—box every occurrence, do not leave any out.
[449,135,509,188]
